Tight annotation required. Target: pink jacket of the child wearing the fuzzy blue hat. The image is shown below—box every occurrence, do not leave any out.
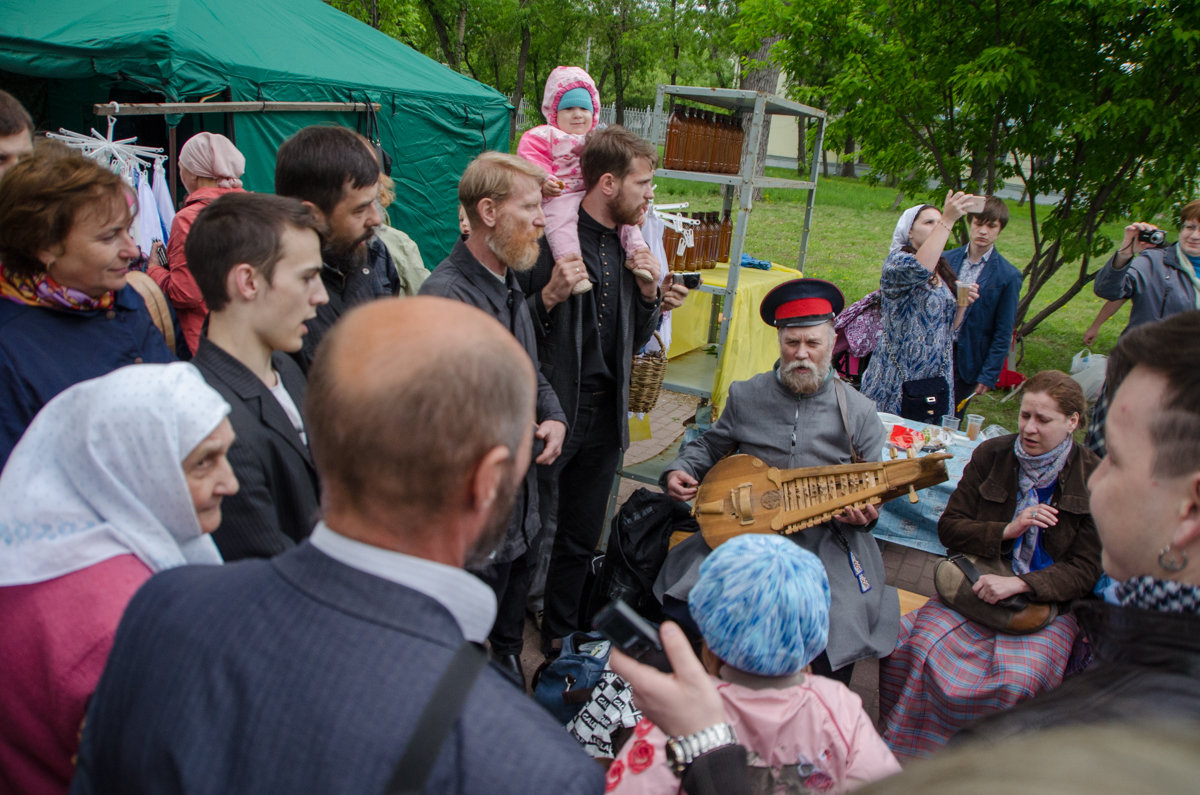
[607,668,900,795]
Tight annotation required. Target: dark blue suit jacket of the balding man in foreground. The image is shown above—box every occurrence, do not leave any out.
[72,543,604,795]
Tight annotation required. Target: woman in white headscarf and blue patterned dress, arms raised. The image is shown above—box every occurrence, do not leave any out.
[862,192,979,424]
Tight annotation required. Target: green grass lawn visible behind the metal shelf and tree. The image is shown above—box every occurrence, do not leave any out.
[655,168,1129,431]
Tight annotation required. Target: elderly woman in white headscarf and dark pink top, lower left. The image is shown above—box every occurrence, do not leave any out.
[0,363,238,793]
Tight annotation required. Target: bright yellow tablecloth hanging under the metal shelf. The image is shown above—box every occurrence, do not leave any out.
[667,264,800,406]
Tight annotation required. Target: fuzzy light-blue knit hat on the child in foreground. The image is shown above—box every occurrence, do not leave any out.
[688,533,829,676]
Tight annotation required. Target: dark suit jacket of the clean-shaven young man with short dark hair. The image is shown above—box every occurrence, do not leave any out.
[192,337,320,561]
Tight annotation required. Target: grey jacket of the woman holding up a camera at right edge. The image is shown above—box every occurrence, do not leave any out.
[1092,245,1196,331]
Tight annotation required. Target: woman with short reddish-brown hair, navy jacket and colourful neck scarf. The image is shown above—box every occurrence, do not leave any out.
[0,154,175,465]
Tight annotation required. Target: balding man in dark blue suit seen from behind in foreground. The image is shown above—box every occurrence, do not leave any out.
[73,297,604,795]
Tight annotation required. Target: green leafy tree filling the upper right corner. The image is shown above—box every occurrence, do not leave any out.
[738,0,1200,333]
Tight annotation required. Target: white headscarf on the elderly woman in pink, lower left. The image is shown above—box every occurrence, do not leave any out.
[0,363,229,585]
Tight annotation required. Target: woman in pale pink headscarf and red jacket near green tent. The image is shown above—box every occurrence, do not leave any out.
[146,132,246,355]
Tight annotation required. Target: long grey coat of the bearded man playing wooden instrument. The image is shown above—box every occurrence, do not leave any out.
[655,364,900,670]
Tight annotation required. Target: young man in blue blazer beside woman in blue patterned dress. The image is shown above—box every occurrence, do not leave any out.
[944,196,1021,413]
